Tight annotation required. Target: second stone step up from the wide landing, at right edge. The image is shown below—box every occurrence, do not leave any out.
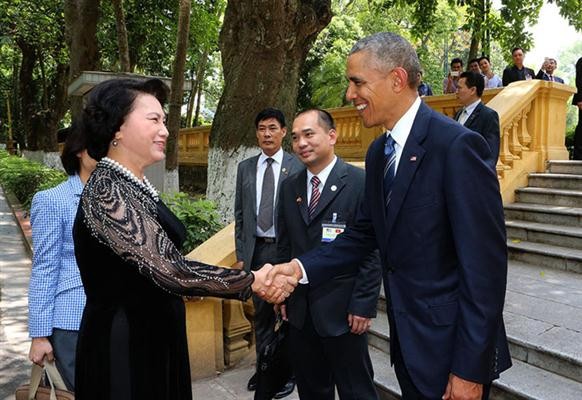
[505,219,582,249]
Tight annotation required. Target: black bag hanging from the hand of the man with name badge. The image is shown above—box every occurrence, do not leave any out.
[254,315,293,400]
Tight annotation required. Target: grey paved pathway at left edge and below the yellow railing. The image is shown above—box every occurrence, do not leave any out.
[0,187,299,400]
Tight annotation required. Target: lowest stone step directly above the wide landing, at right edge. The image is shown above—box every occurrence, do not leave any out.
[507,239,582,274]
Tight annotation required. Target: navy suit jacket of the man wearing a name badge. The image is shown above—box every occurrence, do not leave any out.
[277,158,382,337]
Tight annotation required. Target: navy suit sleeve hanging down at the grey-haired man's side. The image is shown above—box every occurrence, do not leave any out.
[444,132,507,383]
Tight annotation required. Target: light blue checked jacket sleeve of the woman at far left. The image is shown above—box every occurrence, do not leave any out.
[28,192,63,338]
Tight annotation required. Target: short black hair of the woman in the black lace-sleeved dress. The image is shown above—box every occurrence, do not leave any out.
[81,78,169,161]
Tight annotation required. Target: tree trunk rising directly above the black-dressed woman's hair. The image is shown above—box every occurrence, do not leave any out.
[65,0,100,119]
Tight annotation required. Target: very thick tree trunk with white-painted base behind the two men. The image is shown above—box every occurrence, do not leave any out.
[207,0,332,220]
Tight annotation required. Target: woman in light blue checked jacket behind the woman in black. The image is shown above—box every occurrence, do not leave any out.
[28,126,95,391]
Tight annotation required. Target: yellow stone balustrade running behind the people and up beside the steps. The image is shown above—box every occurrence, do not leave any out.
[185,80,575,378]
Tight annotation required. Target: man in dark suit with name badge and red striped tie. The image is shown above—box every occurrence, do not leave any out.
[278,110,381,400]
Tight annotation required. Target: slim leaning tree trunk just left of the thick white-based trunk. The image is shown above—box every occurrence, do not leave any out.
[166,0,192,191]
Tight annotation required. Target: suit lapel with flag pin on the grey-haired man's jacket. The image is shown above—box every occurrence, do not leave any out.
[381,103,431,238]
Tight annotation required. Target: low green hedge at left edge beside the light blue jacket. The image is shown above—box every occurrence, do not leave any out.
[0,151,67,209]
